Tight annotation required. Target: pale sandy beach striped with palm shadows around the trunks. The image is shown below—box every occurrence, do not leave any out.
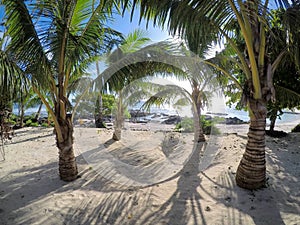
[0,123,300,225]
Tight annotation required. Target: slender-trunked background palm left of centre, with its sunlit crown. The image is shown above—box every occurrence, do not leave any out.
[96,29,183,141]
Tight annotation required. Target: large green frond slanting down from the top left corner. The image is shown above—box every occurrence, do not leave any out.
[2,0,52,89]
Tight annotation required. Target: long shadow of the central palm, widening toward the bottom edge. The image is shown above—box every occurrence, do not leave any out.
[140,143,206,225]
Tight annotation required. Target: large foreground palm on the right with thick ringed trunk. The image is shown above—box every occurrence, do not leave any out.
[125,0,299,189]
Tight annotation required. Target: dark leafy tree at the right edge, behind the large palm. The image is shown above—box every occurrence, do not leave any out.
[268,8,300,132]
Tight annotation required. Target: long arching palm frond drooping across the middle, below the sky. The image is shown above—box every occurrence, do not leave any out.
[98,41,220,93]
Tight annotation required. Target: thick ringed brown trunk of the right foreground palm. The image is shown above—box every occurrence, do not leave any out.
[236,99,267,190]
